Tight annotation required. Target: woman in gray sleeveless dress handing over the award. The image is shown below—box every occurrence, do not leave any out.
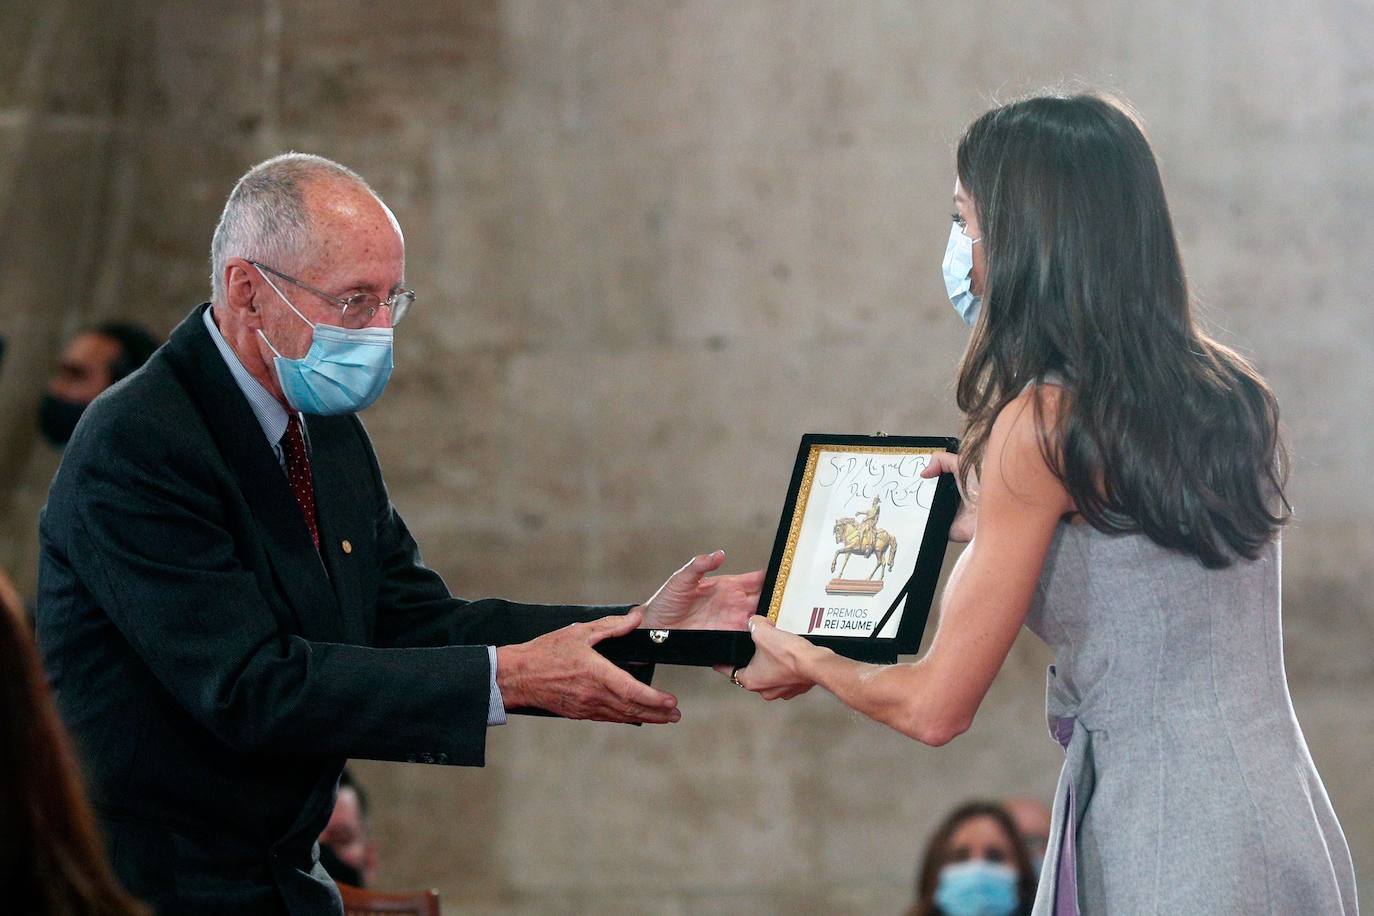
[739,95,1356,913]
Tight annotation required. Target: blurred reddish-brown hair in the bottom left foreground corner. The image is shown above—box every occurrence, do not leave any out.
[0,590,147,916]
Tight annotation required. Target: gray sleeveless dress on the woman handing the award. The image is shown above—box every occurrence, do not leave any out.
[1026,523,1358,916]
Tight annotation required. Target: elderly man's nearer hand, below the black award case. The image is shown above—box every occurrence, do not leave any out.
[496,608,682,724]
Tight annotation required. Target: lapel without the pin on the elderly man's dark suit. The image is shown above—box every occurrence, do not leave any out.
[168,306,342,640]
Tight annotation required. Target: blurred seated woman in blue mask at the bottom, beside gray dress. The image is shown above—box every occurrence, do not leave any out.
[908,802,1039,916]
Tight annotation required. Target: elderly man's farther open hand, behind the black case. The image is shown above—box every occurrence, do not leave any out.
[643,551,764,630]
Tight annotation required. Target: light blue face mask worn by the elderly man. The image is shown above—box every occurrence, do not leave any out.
[258,271,393,416]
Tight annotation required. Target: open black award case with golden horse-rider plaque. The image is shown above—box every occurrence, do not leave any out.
[598,434,959,665]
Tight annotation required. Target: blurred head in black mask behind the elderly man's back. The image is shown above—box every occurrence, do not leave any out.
[38,321,158,448]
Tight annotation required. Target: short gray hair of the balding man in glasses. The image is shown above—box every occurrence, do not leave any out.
[210,152,372,305]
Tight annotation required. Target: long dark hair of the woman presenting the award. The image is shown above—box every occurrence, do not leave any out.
[958,95,1289,569]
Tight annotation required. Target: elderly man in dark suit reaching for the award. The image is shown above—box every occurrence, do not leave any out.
[38,154,761,915]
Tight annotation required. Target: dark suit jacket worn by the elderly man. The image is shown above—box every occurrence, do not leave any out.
[37,306,625,915]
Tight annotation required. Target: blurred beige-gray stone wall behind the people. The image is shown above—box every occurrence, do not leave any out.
[0,0,1374,913]
